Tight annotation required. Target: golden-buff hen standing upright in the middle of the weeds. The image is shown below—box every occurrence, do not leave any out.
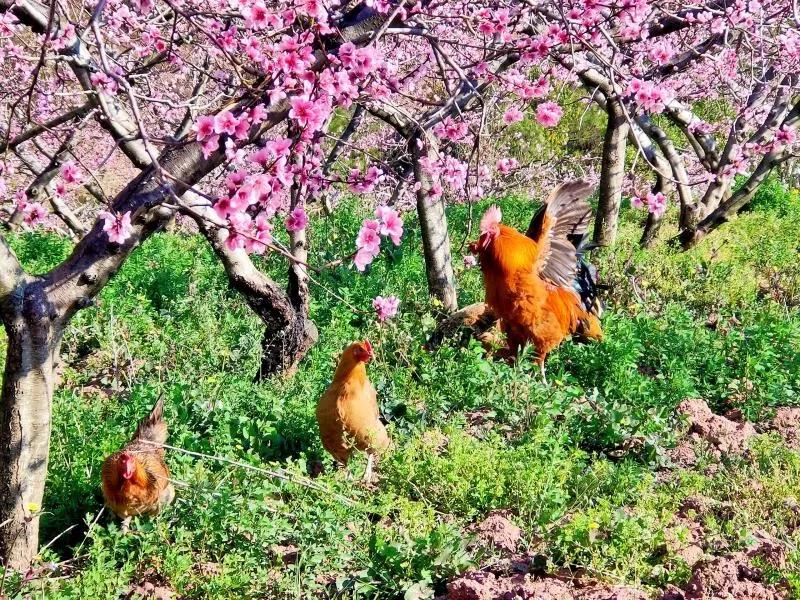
[317,340,390,482]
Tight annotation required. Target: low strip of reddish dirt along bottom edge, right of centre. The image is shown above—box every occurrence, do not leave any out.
[447,571,648,600]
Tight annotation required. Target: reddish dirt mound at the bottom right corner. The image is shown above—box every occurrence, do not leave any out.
[661,553,789,600]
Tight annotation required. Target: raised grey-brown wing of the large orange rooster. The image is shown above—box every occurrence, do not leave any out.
[526,180,592,289]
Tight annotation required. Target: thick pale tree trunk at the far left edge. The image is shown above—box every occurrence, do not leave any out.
[0,282,62,570]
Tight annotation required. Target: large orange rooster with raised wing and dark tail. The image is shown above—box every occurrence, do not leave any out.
[470,181,603,382]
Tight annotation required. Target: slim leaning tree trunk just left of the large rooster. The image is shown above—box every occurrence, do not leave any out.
[410,136,458,313]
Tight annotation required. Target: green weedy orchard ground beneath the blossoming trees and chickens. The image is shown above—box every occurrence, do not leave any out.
[0,182,800,599]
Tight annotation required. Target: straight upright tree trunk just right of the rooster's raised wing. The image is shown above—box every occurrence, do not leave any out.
[594,98,630,246]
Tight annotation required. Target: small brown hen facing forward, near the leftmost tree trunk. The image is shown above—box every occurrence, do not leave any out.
[102,397,175,530]
